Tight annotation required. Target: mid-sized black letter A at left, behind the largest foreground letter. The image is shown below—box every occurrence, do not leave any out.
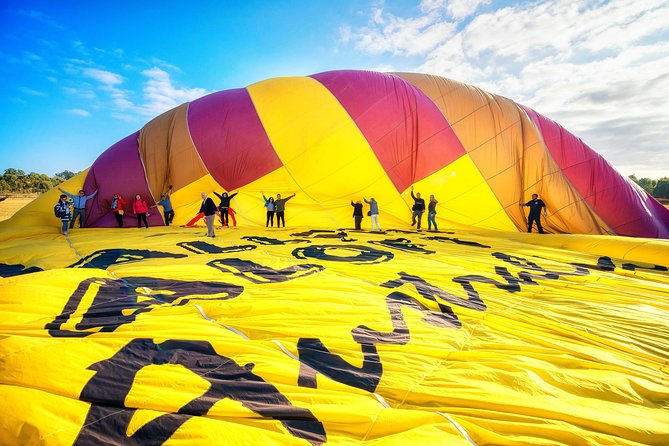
[44,277,244,337]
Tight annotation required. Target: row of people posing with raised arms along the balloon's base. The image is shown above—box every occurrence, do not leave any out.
[54,185,546,237]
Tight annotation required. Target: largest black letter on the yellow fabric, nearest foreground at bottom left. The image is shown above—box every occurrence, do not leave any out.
[74,339,327,446]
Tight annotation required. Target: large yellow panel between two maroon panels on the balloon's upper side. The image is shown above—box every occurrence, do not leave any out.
[248,77,397,205]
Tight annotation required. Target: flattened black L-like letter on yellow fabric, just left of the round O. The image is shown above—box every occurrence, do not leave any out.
[207,259,325,283]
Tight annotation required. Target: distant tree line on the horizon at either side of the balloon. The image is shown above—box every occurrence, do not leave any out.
[0,168,669,199]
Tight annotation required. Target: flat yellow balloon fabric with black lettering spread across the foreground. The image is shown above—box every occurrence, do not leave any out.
[0,225,669,445]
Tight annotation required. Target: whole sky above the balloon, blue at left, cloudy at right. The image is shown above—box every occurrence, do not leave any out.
[0,0,669,178]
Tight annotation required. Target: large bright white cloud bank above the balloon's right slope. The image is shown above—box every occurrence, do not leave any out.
[342,0,669,177]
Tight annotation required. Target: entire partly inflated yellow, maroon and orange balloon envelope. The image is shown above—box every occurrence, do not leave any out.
[0,71,669,445]
